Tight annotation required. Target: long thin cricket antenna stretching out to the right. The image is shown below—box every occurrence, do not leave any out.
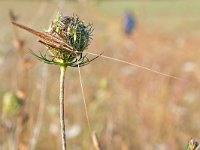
[84,52,180,80]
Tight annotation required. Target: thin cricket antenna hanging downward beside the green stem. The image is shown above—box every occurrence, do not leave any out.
[78,64,92,133]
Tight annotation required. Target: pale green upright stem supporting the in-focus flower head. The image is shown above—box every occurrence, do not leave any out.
[60,66,67,150]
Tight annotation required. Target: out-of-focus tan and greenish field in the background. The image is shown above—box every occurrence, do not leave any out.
[0,0,200,150]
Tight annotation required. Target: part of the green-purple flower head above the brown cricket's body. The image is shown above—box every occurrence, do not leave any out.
[48,13,93,52]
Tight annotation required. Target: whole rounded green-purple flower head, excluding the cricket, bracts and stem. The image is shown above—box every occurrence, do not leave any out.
[41,13,93,66]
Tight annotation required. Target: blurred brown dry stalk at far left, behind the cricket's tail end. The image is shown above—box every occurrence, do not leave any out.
[9,10,30,150]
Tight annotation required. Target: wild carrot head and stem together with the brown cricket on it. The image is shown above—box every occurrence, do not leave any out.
[13,14,98,150]
